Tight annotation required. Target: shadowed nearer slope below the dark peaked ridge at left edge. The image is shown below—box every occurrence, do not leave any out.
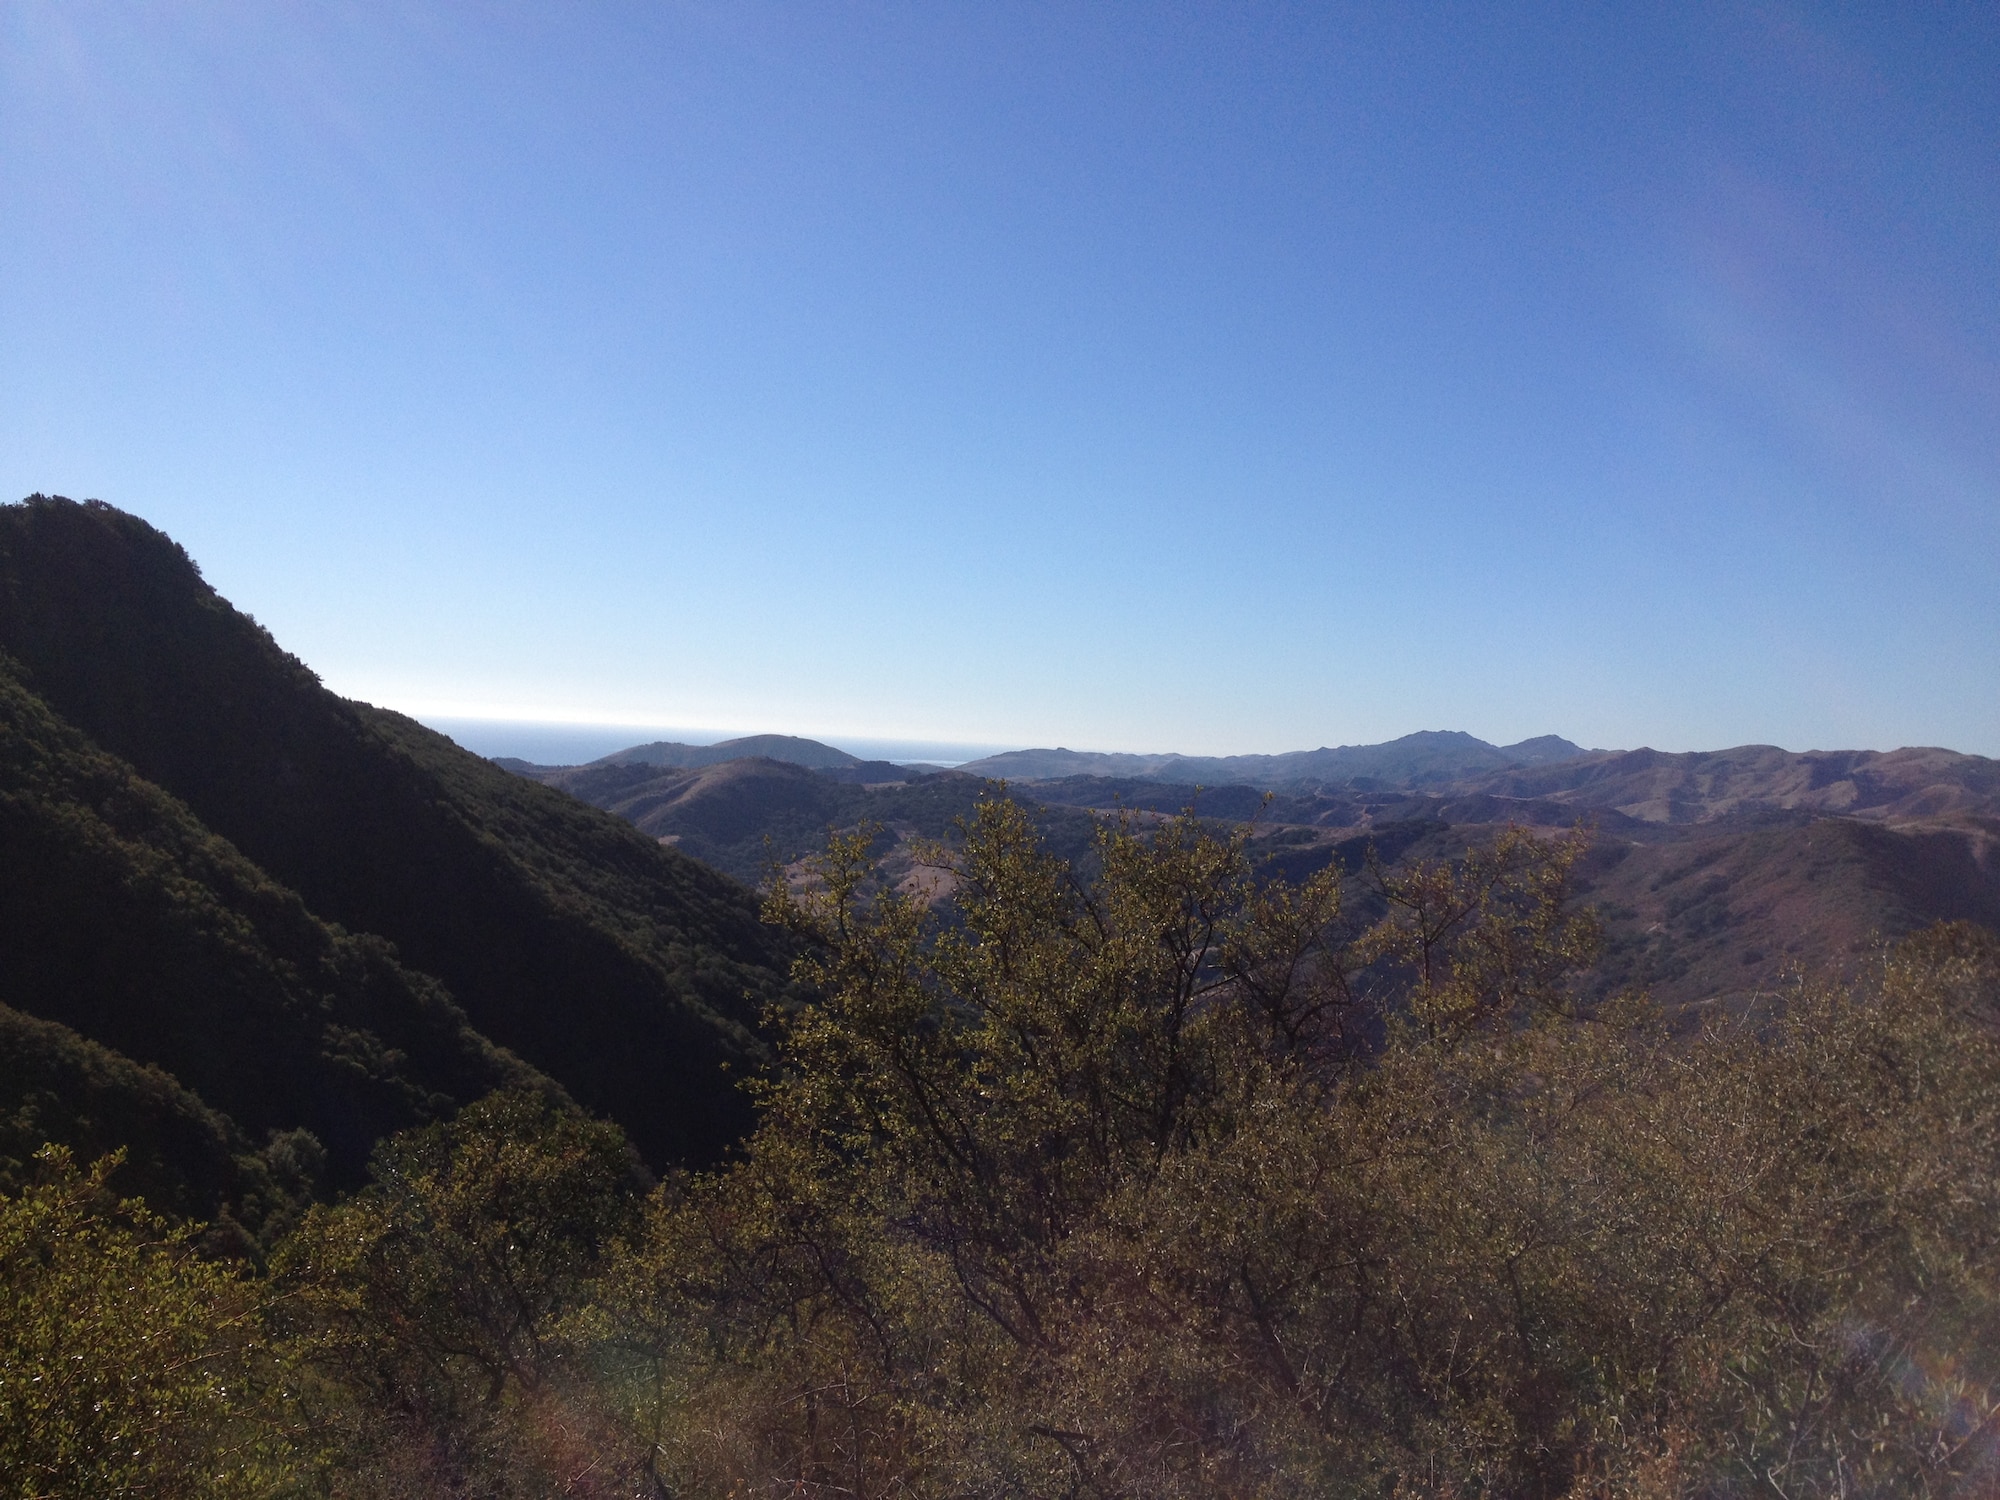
[0,652,538,1182]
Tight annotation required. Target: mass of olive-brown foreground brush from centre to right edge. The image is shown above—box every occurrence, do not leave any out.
[600,804,2000,1496]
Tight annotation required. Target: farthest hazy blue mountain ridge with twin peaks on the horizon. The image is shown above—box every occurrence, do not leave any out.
[958,730,1588,788]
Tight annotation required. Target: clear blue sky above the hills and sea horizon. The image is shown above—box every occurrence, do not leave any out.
[0,0,2000,754]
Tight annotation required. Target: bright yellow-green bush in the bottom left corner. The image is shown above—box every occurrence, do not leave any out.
[0,1148,286,1500]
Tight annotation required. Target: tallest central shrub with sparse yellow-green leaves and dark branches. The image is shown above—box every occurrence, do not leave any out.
[764,800,1346,1256]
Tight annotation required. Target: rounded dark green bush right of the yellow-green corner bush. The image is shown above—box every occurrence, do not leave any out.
[274,1092,638,1496]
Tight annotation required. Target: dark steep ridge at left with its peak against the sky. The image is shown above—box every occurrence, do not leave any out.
[0,496,786,1166]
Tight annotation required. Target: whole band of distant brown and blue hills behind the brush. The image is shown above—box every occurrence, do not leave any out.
[514,732,2000,1006]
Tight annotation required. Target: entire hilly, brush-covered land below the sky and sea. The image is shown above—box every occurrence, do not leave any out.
[11,496,2000,1500]
